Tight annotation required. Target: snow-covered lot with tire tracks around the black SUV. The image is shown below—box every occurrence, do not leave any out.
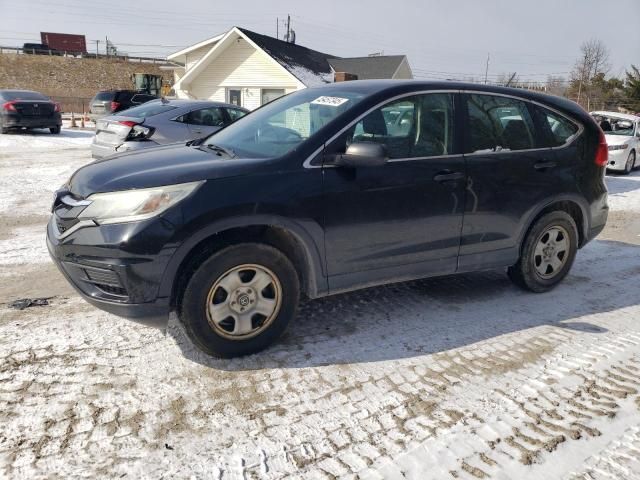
[0,130,640,480]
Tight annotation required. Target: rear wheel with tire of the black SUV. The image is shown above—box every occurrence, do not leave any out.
[508,211,578,292]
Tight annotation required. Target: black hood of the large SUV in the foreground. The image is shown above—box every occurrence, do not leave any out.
[68,143,265,198]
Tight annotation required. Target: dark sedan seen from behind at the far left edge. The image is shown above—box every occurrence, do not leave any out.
[0,90,62,133]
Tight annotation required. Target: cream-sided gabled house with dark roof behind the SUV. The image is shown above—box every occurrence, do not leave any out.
[167,27,412,109]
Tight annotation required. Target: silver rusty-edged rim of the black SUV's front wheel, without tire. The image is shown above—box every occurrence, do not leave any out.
[207,264,282,340]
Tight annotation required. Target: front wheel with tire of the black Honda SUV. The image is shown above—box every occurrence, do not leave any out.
[180,243,300,358]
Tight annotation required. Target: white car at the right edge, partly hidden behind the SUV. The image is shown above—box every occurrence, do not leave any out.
[591,112,640,174]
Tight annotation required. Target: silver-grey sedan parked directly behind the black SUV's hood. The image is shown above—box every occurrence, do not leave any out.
[91,99,248,158]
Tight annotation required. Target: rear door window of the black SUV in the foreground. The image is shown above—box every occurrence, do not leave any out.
[465,94,542,153]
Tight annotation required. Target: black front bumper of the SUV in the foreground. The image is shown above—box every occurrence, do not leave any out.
[47,215,175,328]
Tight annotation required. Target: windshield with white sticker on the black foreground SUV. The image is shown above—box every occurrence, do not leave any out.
[203,88,364,158]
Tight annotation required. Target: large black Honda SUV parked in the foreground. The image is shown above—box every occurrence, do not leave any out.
[47,81,608,357]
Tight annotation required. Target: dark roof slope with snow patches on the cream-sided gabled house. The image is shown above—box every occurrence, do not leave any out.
[236,27,337,86]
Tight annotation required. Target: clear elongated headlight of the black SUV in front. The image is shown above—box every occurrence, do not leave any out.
[78,182,204,224]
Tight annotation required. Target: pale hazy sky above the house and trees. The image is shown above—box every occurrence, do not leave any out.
[0,0,640,81]
